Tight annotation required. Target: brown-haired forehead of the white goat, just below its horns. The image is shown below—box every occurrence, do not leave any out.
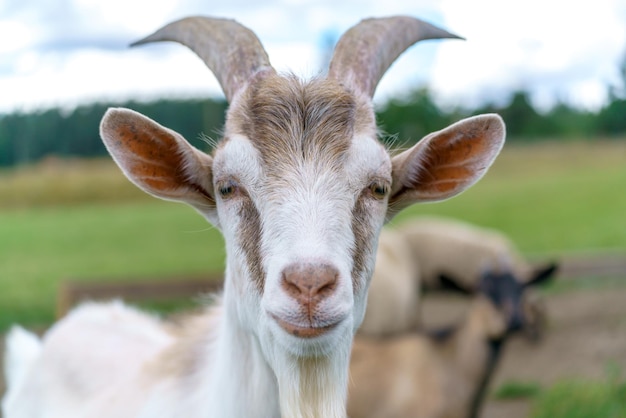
[227,75,376,172]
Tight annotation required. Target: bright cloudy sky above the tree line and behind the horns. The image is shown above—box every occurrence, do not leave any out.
[0,0,626,113]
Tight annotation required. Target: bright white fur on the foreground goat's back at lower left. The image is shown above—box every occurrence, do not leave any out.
[3,302,172,418]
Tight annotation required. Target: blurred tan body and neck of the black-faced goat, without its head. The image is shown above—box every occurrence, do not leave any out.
[348,302,504,418]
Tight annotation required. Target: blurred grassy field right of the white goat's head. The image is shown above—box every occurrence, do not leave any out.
[394,141,626,254]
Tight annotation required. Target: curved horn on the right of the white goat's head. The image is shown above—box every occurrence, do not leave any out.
[328,16,462,97]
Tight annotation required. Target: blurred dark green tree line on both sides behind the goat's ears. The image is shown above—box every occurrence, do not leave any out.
[0,88,626,167]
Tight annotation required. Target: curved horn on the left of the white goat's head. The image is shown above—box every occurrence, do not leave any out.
[131,16,272,102]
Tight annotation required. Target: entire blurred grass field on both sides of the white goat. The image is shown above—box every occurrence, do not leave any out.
[0,140,626,331]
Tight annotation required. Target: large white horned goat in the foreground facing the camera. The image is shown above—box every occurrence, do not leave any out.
[3,16,505,418]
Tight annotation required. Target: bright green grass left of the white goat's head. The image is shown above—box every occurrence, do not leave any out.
[0,200,224,329]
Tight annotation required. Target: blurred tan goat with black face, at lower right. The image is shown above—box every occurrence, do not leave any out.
[348,271,549,418]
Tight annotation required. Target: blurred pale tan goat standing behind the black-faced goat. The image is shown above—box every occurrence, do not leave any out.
[359,217,558,340]
